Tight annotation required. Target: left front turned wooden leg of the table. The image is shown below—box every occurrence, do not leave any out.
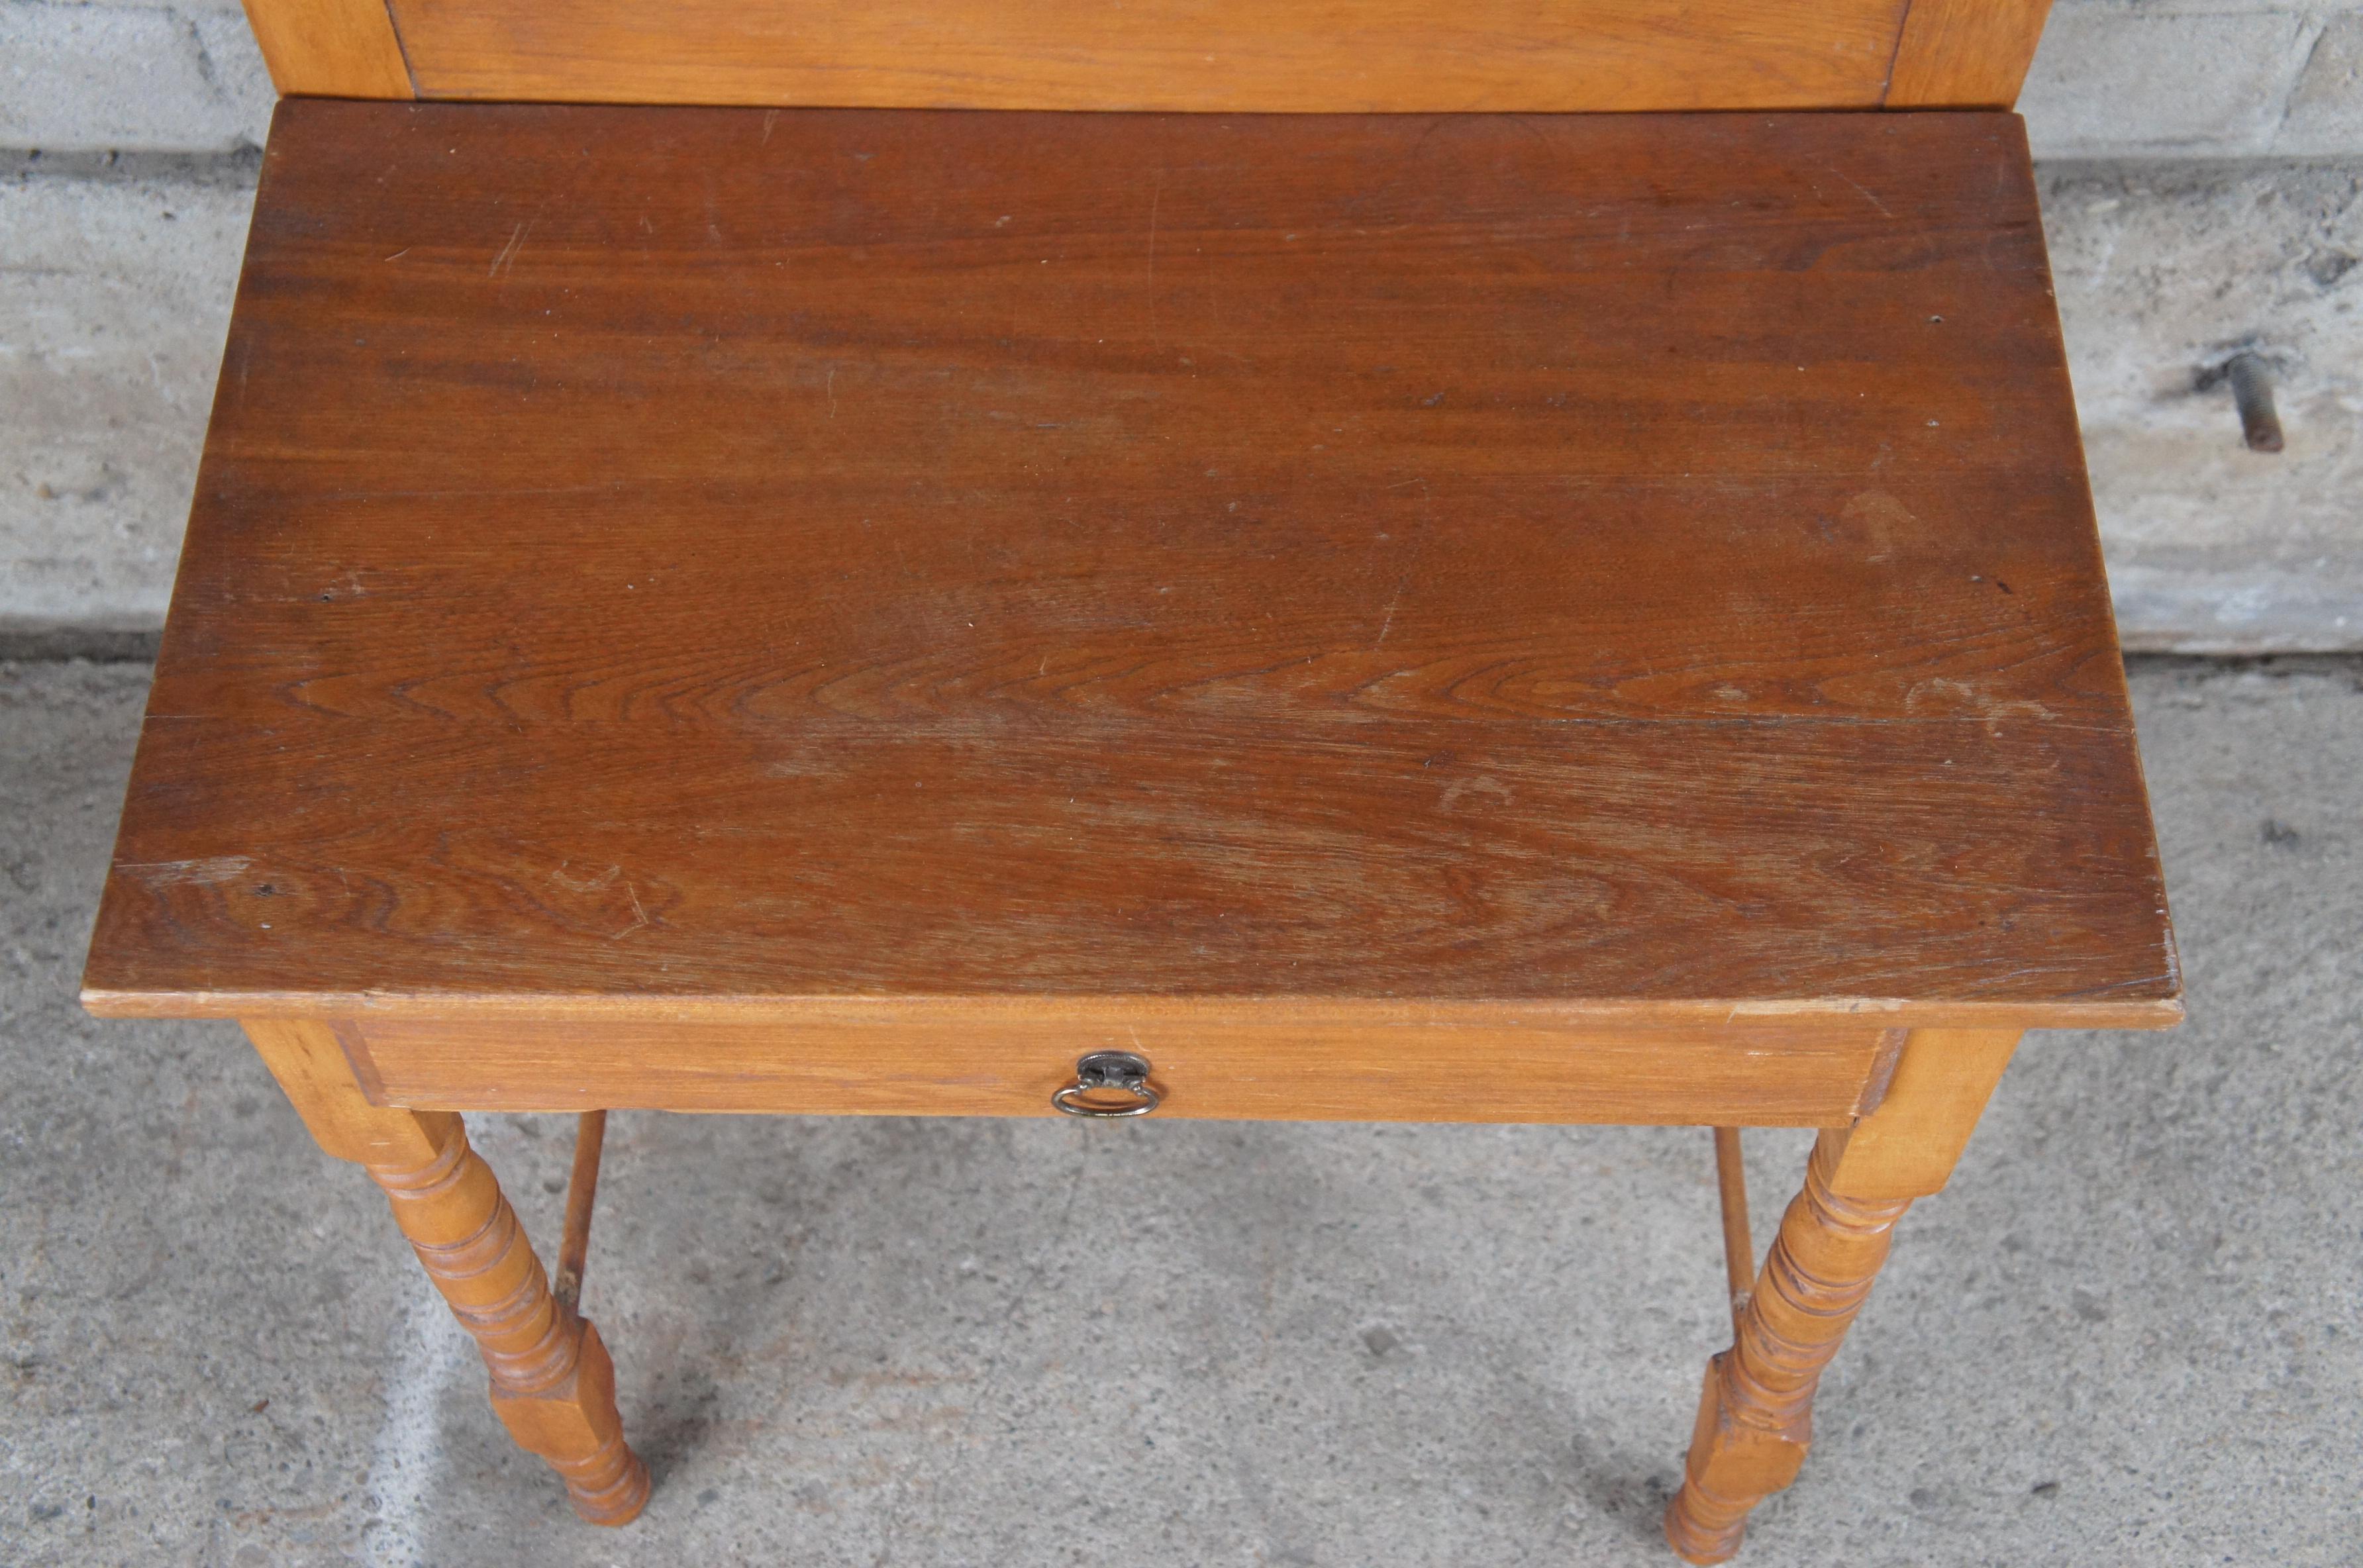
[246,1020,648,1526]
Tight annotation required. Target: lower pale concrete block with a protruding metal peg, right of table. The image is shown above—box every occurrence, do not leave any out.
[2039,161,2363,654]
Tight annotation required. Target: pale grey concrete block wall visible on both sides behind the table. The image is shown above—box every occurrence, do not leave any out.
[0,0,2363,654]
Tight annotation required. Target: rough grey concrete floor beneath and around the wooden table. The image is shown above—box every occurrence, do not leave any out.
[0,663,2363,1568]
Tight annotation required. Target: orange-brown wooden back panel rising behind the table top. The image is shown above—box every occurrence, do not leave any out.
[246,0,2048,113]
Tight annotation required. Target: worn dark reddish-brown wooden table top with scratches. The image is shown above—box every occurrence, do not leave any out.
[85,99,2179,1025]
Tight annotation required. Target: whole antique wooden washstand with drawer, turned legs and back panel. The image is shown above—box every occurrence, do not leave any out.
[85,0,2179,1563]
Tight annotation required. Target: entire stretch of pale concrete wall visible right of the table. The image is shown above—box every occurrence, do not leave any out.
[2018,0,2363,654]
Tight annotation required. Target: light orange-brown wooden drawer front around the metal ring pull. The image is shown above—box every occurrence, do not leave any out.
[340,1008,1902,1126]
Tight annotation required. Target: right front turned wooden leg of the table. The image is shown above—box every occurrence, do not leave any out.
[1666,1030,2018,1563]
